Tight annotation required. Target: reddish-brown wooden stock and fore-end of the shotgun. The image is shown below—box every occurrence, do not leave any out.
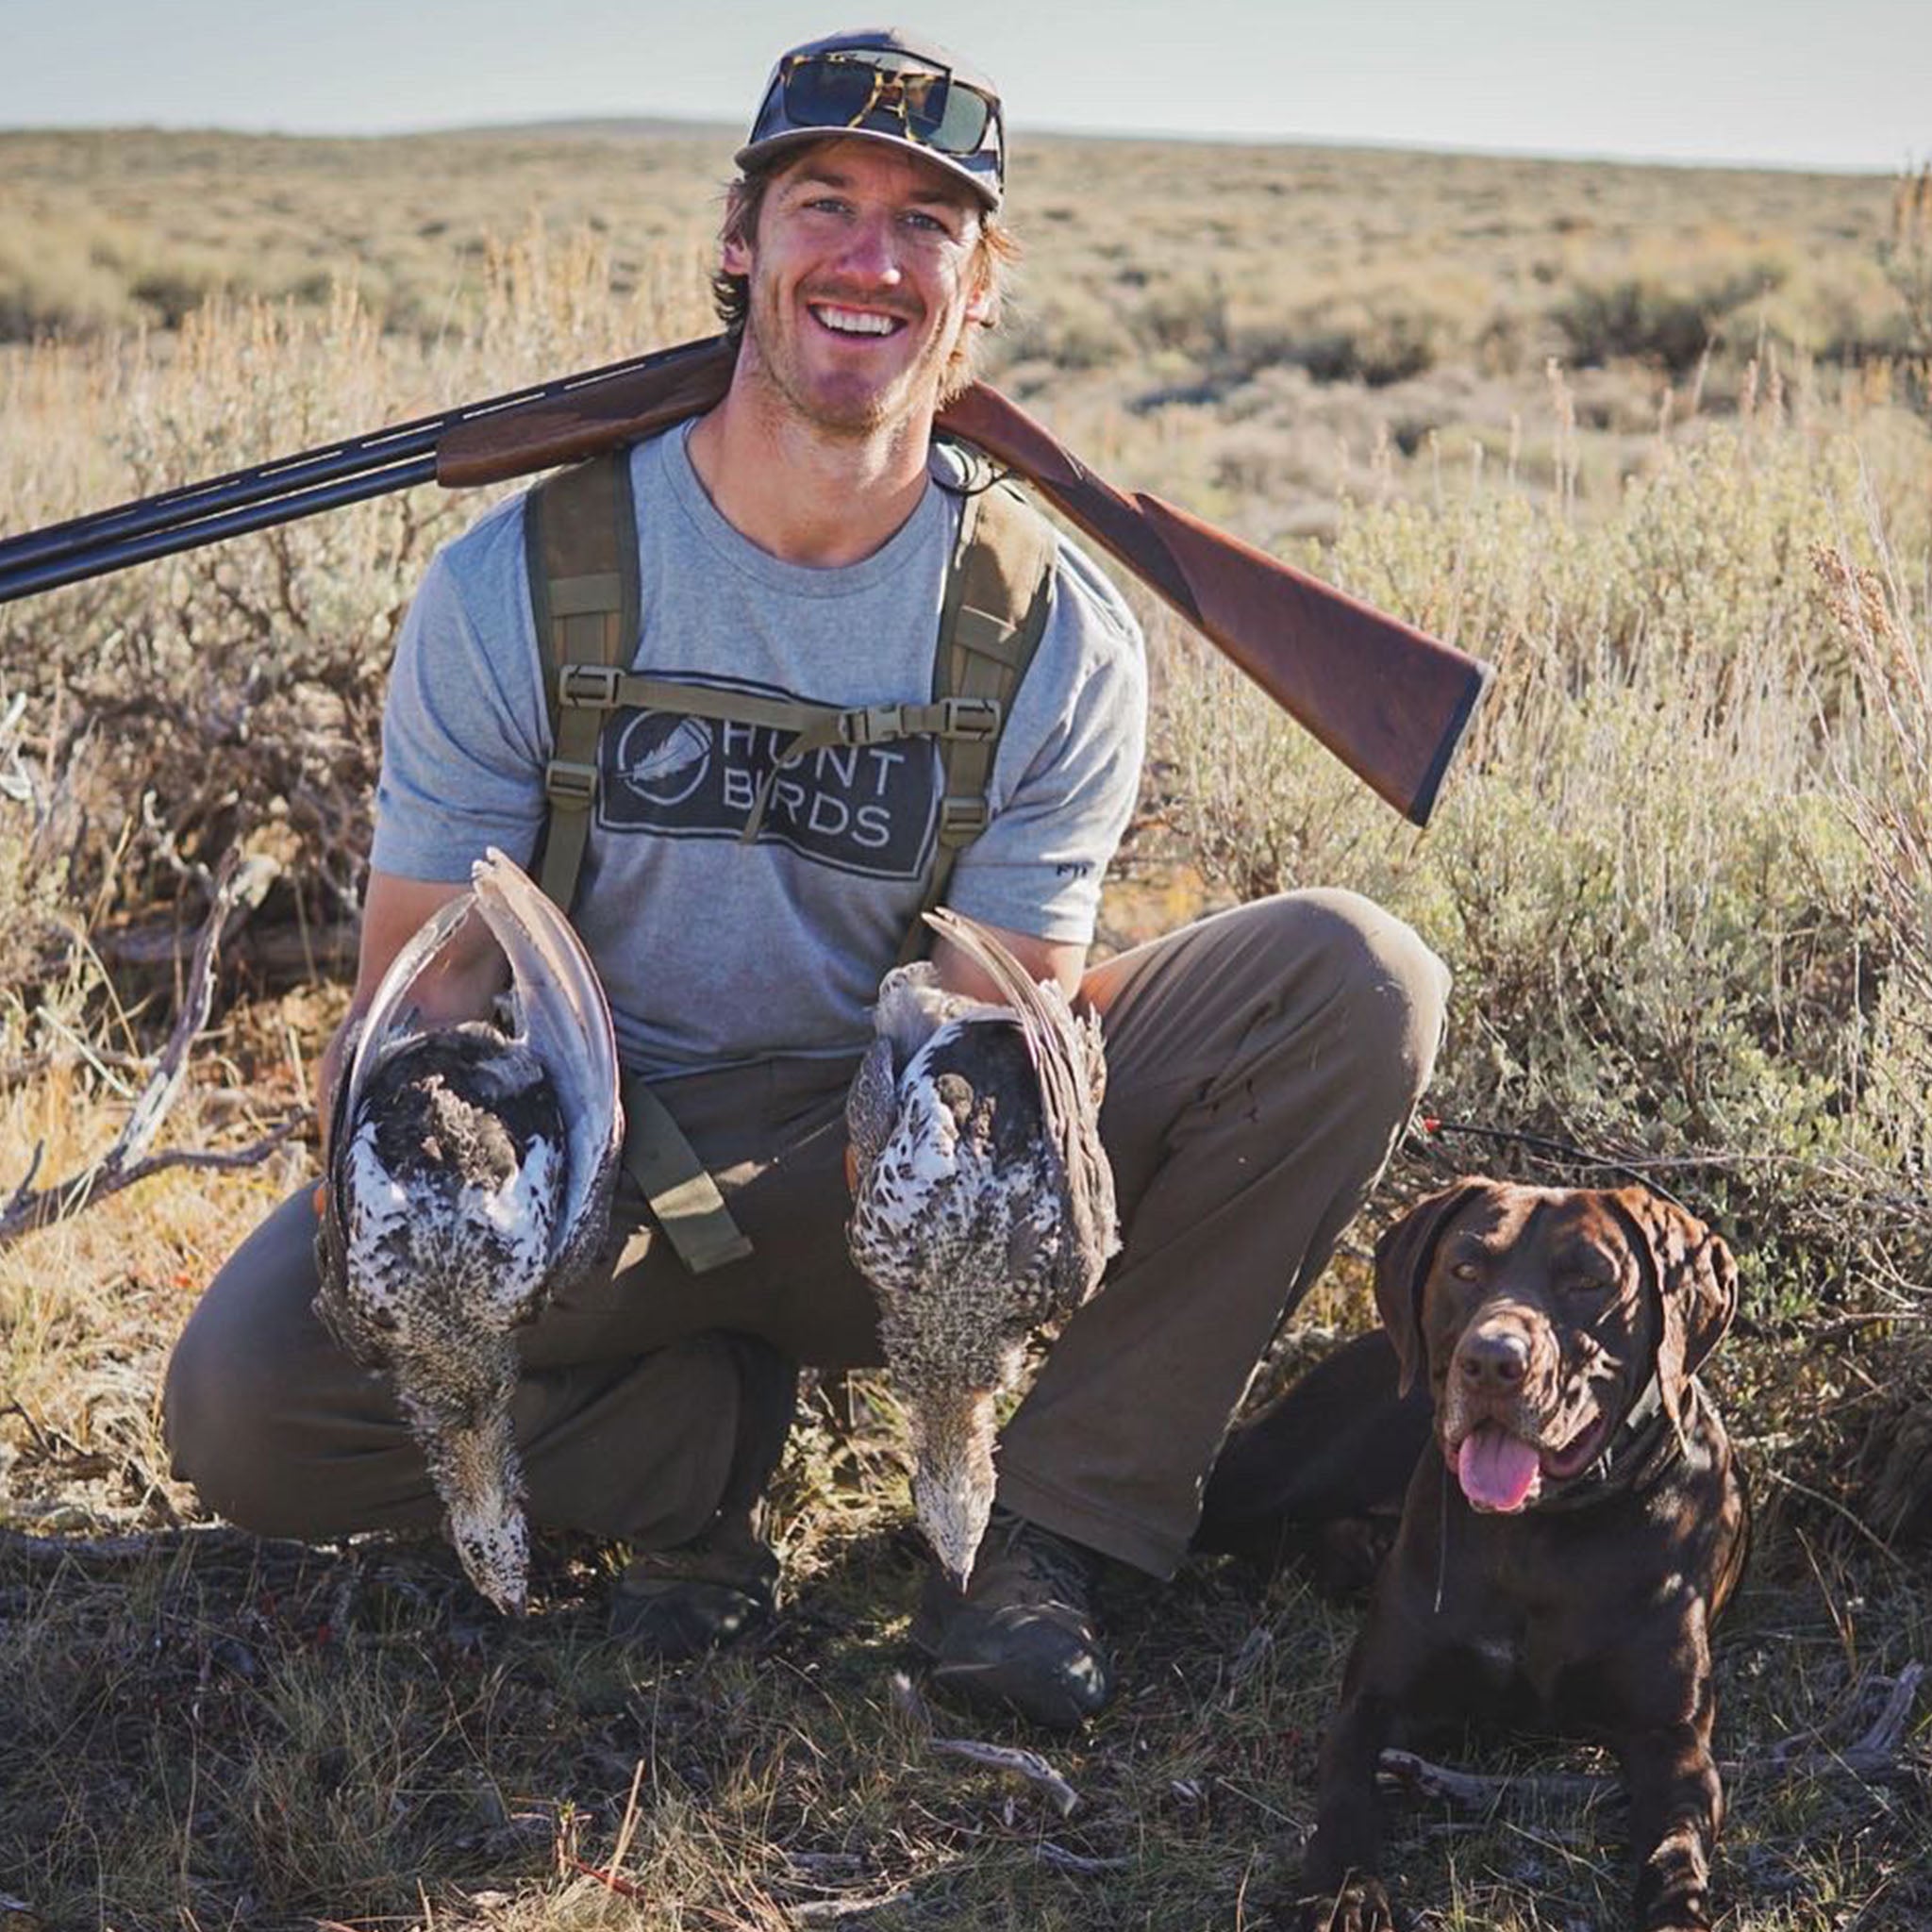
[437,336,1490,824]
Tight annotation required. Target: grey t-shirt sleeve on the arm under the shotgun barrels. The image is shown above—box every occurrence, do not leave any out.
[371,507,551,885]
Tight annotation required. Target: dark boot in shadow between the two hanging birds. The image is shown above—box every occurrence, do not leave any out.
[610,1335,798,1663]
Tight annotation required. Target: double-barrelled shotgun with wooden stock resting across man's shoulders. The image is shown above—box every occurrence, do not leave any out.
[0,336,1490,824]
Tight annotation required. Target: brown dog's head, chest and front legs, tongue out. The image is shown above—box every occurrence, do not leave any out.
[1302,1178,1746,1932]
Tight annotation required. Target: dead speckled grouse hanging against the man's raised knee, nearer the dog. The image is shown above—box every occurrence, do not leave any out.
[846,910,1121,1588]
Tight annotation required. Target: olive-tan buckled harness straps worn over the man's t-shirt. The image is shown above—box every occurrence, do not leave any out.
[524,444,1055,1275]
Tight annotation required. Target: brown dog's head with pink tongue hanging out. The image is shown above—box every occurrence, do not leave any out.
[1375,1178,1737,1511]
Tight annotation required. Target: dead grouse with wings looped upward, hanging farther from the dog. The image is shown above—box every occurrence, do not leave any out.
[315,850,622,1613]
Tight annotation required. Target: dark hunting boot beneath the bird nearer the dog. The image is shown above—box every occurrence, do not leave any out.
[912,1508,1113,1731]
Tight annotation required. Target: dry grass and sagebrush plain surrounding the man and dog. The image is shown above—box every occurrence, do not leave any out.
[0,129,1932,1932]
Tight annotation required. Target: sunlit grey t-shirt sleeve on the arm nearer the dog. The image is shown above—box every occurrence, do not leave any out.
[947,537,1148,944]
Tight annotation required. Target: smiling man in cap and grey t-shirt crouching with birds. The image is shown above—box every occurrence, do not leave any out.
[166,31,1445,1724]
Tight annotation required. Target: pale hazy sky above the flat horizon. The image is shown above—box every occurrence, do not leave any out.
[0,0,1932,172]
